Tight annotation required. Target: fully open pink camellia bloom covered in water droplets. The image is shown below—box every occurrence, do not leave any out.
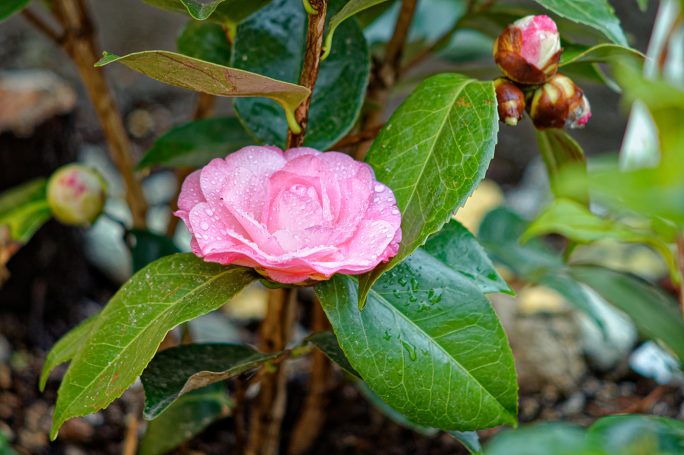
[175,146,401,283]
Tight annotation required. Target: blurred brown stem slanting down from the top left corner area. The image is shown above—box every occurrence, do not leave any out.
[51,0,147,228]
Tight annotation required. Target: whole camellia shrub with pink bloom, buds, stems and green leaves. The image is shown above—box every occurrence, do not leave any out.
[0,0,684,455]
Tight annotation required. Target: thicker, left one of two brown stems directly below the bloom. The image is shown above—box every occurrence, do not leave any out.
[245,289,297,455]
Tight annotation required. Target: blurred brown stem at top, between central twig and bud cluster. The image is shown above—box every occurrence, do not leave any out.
[354,0,416,160]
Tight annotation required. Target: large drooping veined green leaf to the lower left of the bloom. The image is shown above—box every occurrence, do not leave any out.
[50,253,255,439]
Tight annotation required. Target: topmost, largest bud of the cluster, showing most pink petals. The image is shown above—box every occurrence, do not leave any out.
[494,16,561,85]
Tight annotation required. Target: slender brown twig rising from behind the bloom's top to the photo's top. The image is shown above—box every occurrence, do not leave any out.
[287,0,328,148]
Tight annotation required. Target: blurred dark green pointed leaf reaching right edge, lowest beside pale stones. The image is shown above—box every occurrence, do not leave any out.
[570,266,684,363]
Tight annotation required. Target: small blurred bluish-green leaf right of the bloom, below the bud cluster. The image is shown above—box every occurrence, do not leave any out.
[478,207,564,281]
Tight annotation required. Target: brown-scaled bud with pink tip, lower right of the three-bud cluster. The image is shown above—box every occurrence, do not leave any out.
[528,74,591,129]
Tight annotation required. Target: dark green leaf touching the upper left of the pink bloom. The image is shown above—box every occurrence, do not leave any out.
[137,117,254,169]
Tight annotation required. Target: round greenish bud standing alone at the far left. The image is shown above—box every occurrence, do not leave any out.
[47,164,107,226]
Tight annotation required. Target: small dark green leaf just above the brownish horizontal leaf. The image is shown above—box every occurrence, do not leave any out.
[176,20,231,66]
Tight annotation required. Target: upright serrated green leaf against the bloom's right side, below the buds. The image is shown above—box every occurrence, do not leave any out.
[359,74,499,305]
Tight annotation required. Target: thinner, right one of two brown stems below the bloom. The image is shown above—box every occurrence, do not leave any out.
[288,300,332,455]
